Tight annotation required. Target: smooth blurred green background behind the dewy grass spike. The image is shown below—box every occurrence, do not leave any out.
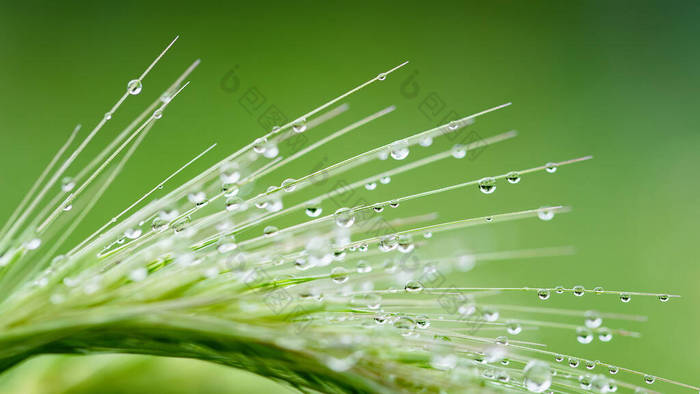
[0,1,700,392]
